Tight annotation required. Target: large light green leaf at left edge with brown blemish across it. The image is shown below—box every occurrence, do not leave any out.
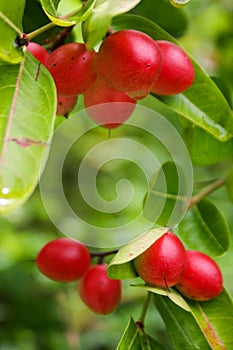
[0,51,56,215]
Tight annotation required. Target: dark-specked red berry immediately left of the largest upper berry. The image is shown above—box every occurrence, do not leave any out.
[46,43,96,95]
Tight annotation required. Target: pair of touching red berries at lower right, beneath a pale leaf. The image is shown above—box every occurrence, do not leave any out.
[134,231,223,301]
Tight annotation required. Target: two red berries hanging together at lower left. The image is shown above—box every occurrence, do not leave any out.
[36,238,121,315]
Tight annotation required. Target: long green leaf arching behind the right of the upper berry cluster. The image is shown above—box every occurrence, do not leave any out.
[112,15,233,141]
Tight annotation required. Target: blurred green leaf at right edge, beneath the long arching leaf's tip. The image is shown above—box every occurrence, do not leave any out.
[183,127,233,165]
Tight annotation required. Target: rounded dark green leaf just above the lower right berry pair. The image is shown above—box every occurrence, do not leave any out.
[178,198,230,256]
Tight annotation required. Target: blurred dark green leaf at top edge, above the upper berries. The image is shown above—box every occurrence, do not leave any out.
[131,0,188,37]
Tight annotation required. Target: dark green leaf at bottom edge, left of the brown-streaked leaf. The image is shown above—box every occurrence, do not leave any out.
[154,294,211,350]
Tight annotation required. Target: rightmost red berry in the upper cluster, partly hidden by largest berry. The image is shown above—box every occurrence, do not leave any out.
[151,40,194,95]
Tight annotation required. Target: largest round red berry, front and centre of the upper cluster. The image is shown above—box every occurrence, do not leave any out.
[96,30,161,98]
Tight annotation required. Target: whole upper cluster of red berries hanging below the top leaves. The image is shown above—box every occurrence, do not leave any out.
[27,30,194,128]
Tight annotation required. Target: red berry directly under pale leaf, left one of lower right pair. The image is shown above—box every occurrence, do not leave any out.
[134,231,186,288]
